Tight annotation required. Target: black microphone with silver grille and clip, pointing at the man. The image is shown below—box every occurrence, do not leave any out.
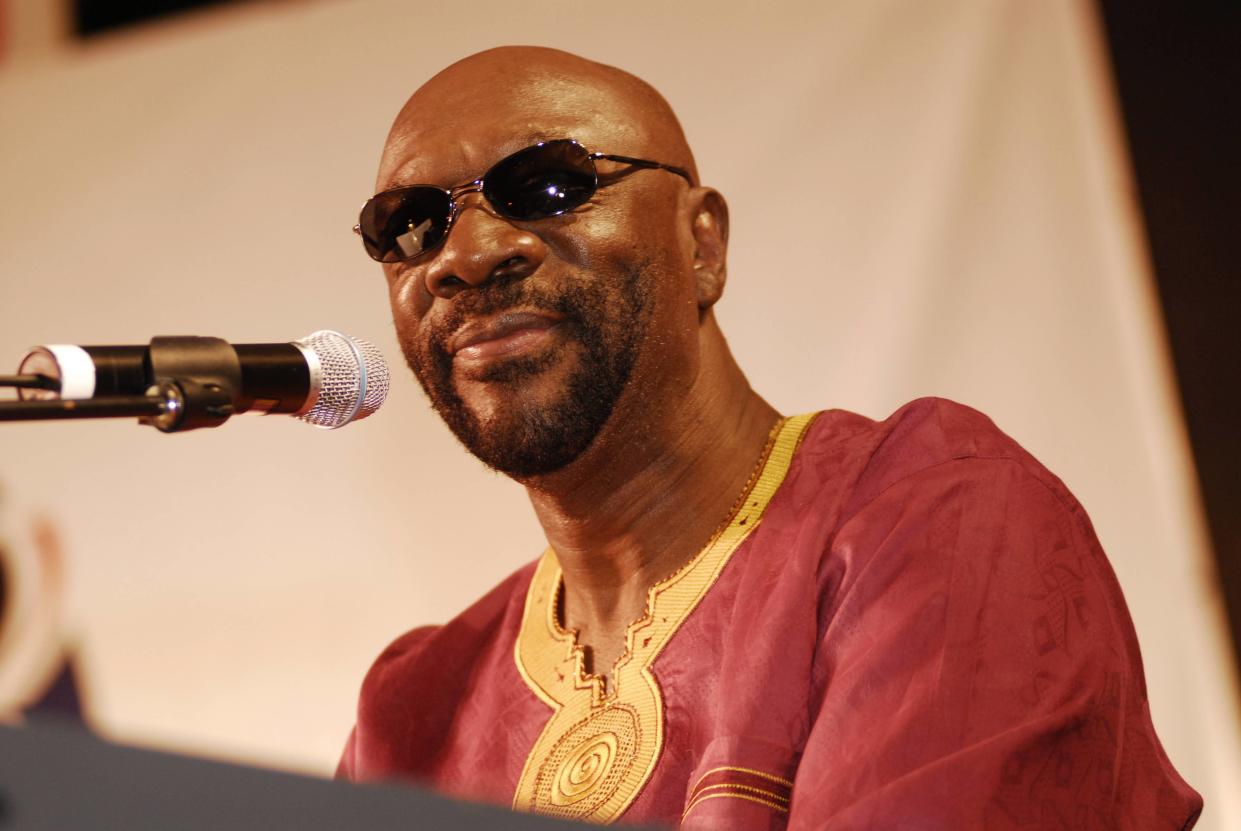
[17,329,388,429]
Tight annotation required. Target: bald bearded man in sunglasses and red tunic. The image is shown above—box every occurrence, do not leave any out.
[340,48,1201,829]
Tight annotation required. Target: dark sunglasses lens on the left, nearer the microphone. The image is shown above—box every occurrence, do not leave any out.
[357,187,453,263]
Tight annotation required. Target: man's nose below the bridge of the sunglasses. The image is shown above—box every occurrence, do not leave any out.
[423,193,547,299]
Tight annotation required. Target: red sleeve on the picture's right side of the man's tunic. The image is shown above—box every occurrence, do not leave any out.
[788,458,1201,831]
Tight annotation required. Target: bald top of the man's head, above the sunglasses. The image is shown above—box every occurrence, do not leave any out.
[379,46,697,190]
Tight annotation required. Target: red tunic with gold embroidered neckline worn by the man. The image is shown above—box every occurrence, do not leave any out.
[339,399,1203,830]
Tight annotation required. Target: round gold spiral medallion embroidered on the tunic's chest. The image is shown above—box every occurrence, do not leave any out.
[532,703,642,819]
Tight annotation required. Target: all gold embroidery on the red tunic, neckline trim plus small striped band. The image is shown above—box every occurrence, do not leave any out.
[513,414,814,824]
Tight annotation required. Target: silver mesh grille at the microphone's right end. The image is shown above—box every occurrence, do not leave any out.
[297,329,388,429]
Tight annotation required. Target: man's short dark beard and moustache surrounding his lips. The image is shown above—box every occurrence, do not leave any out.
[401,265,650,479]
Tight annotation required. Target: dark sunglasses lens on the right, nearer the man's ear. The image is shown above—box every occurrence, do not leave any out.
[483,140,598,220]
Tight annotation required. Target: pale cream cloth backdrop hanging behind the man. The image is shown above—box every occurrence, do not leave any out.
[0,0,1241,830]
